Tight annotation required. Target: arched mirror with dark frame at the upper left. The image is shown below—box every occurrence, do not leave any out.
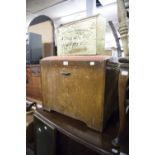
[28,15,56,62]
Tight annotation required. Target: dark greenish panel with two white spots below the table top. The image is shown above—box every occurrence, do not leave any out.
[34,118,56,155]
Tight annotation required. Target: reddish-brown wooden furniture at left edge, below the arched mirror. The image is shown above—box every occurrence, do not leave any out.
[26,64,42,101]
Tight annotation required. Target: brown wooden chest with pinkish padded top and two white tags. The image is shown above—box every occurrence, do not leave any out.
[40,55,117,132]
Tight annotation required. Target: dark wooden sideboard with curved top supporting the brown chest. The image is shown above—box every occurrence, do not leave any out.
[34,109,129,155]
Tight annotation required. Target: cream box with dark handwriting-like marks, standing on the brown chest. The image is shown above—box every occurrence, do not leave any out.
[56,15,106,56]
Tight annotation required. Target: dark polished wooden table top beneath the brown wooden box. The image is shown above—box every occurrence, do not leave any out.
[34,108,129,155]
